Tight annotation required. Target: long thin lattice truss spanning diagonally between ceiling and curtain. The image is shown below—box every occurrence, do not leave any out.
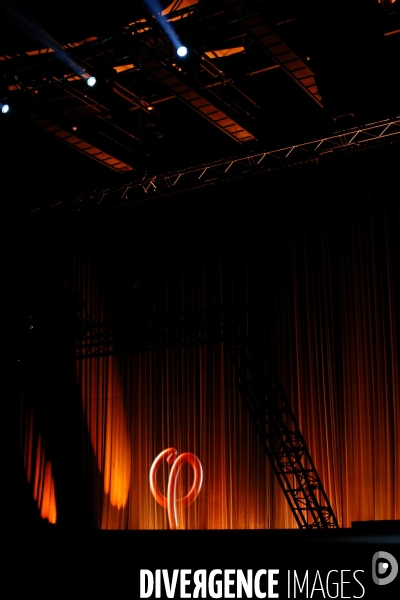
[32,116,400,217]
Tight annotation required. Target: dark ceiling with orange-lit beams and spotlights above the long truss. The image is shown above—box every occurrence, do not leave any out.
[0,0,400,216]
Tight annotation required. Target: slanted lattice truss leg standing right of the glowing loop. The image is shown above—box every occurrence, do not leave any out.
[231,336,339,529]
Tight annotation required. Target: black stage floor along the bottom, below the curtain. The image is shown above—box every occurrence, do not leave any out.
[5,521,400,600]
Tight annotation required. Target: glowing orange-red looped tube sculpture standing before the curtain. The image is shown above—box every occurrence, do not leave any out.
[150,448,203,529]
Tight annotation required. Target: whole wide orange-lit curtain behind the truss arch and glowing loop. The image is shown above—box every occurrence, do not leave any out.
[27,151,400,529]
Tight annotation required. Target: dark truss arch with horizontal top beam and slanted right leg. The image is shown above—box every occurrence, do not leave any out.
[75,307,338,529]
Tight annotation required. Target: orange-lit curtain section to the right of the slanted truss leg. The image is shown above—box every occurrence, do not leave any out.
[269,190,400,527]
